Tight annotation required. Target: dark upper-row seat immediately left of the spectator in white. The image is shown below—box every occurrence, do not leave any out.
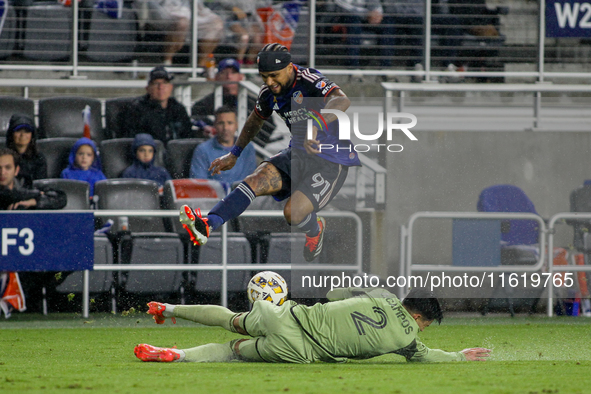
[86,7,137,63]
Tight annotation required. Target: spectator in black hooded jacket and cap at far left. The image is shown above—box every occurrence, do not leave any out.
[6,114,47,187]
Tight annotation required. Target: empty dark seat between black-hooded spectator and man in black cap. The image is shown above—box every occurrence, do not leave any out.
[39,97,108,142]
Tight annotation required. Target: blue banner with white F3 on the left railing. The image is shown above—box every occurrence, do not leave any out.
[0,212,94,271]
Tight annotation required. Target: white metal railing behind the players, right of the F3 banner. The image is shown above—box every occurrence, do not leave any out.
[82,210,363,317]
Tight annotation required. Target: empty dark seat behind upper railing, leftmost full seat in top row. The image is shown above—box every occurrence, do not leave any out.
[23,2,72,61]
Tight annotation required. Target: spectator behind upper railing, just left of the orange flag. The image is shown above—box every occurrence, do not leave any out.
[212,0,265,65]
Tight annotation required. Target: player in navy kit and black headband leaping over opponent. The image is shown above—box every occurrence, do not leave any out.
[180,43,361,261]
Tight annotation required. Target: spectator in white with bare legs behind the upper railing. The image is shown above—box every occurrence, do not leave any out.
[134,0,224,66]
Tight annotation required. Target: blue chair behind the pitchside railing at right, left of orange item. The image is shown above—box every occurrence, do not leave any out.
[477,185,543,317]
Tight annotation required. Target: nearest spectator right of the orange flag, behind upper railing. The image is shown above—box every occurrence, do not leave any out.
[335,0,383,68]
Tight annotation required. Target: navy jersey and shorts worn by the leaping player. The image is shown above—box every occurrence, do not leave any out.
[254,65,361,210]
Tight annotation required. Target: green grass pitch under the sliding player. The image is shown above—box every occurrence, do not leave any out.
[0,313,591,394]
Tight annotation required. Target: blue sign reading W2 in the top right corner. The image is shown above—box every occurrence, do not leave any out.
[546,0,591,38]
